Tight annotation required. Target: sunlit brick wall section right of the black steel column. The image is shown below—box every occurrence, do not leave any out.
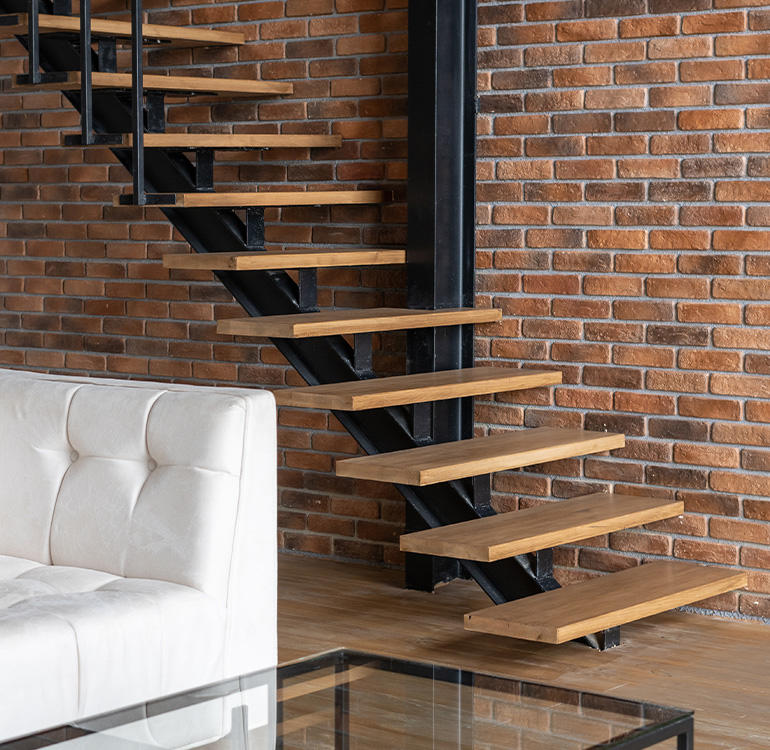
[478,0,770,617]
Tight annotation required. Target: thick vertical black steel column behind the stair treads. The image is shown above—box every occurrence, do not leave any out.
[406,0,476,588]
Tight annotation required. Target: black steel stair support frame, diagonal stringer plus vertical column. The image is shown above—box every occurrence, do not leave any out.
[0,0,612,646]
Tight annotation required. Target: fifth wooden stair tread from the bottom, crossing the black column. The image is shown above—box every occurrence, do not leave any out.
[217,307,502,339]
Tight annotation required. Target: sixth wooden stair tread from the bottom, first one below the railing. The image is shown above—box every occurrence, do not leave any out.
[163,248,406,271]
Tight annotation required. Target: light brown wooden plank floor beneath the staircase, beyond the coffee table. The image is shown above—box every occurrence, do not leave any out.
[278,555,770,750]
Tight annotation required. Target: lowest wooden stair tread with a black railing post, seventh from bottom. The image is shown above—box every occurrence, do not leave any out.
[114,190,391,208]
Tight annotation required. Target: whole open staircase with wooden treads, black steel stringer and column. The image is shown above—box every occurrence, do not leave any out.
[0,0,746,647]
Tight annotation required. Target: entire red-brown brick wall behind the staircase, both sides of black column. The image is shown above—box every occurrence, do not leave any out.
[0,0,770,618]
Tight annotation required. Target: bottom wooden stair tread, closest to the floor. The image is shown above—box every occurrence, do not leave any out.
[465,561,748,643]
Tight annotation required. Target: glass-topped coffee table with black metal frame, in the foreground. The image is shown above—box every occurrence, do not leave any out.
[0,649,693,750]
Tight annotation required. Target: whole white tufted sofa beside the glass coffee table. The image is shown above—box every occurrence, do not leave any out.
[0,370,277,739]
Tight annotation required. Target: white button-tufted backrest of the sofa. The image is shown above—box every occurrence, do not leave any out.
[0,370,276,616]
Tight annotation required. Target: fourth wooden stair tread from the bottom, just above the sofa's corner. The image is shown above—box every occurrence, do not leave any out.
[275,367,562,411]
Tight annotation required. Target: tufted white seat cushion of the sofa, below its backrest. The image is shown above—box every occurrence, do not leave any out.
[0,556,225,737]
